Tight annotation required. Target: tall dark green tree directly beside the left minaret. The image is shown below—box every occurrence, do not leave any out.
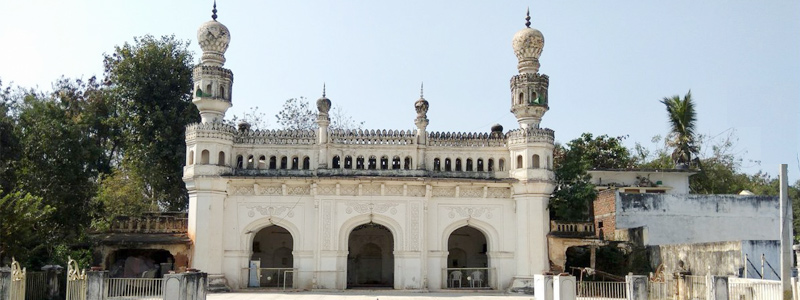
[104,35,200,210]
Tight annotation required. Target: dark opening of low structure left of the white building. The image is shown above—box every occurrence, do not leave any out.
[106,249,175,278]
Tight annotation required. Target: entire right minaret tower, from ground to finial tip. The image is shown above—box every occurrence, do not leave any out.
[506,11,555,290]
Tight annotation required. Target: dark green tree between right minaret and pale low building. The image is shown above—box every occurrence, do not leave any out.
[550,133,635,221]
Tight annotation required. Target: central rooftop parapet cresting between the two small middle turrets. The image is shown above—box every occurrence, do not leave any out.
[328,129,417,145]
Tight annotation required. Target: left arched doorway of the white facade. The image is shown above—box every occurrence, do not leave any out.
[246,225,294,288]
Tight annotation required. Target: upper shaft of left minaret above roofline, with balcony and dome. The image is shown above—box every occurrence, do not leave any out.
[192,1,233,123]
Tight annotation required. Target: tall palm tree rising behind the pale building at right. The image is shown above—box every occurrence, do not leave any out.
[661,90,697,168]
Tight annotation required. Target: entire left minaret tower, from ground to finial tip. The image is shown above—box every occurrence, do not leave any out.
[183,3,236,291]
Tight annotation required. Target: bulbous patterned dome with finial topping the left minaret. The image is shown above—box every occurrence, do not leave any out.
[197,1,231,67]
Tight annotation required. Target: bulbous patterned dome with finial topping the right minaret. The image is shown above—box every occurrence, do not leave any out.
[511,9,544,73]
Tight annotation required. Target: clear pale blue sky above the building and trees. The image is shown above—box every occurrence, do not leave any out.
[0,0,800,180]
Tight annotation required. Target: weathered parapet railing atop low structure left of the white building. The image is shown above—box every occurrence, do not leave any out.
[108,213,189,233]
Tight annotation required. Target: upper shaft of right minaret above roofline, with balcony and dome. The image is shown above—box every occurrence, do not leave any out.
[511,11,550,128]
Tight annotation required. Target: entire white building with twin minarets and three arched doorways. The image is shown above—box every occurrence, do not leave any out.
[184,10,554,290]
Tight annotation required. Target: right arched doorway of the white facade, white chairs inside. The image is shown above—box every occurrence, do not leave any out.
[445,226,490,288]
